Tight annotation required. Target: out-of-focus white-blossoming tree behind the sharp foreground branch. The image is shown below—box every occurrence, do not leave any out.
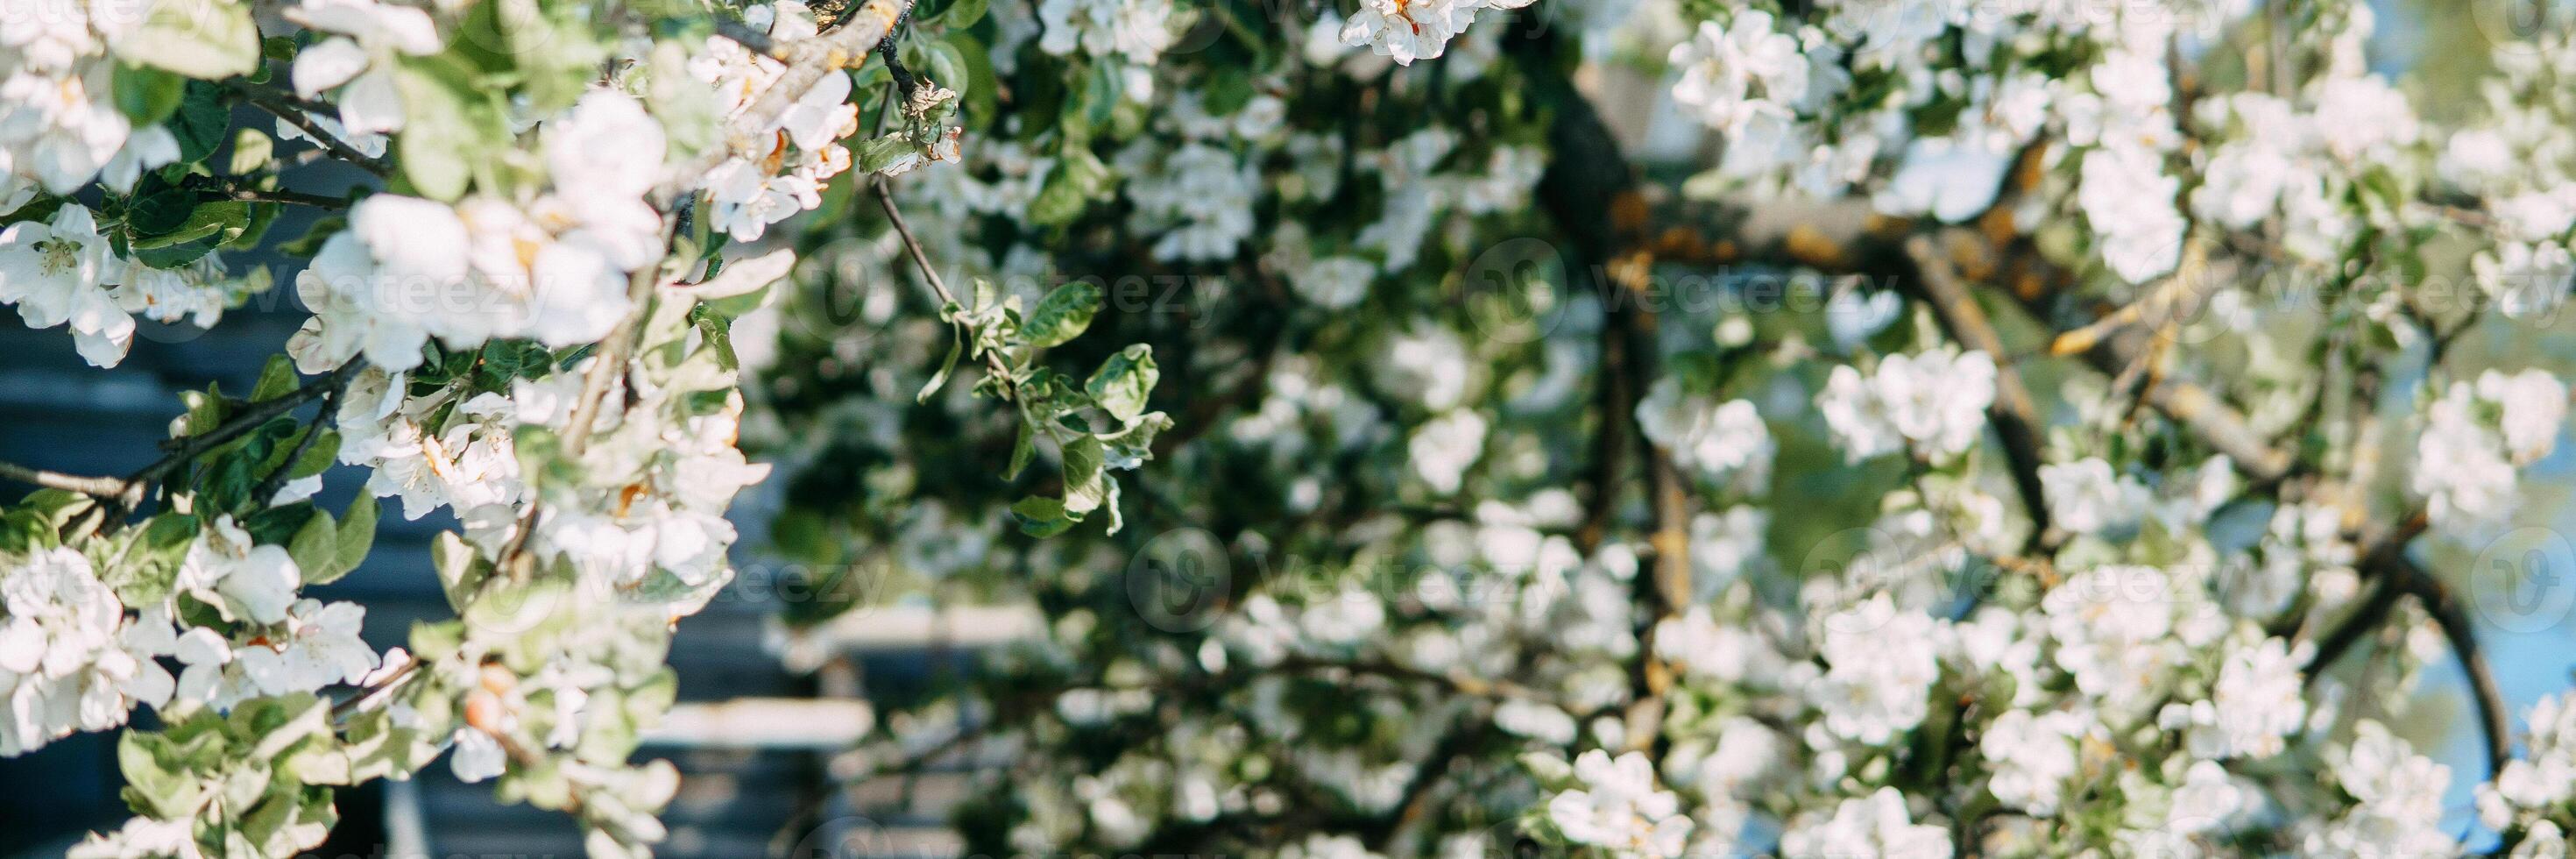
[768,3,2565,856]
